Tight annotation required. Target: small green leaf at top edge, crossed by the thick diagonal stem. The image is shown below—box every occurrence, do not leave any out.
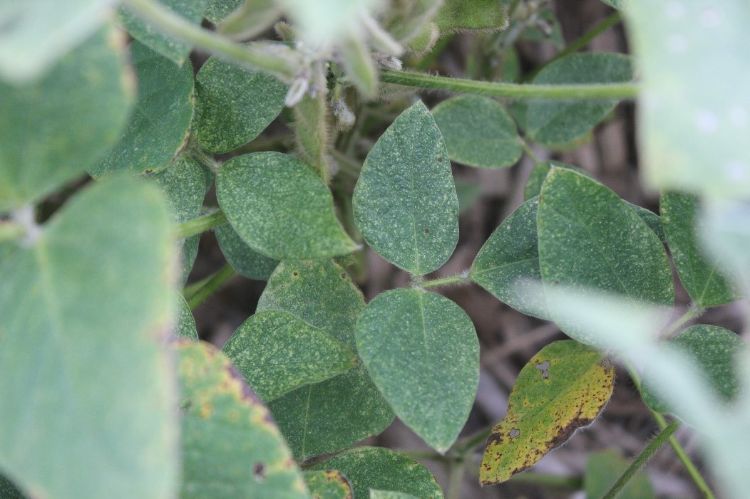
[120,0,209,66]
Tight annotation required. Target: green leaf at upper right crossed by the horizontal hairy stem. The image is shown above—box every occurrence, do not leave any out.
[526,53,633,146]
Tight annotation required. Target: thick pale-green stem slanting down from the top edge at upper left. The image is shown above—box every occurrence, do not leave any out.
[124,0,298,81]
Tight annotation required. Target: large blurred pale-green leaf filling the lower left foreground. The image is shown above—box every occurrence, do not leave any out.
[0,178,178,499]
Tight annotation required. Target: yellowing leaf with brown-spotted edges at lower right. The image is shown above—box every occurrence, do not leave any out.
[479,340,615,485]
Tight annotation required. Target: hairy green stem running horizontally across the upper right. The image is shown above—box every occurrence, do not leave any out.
[381,71,639,100]
